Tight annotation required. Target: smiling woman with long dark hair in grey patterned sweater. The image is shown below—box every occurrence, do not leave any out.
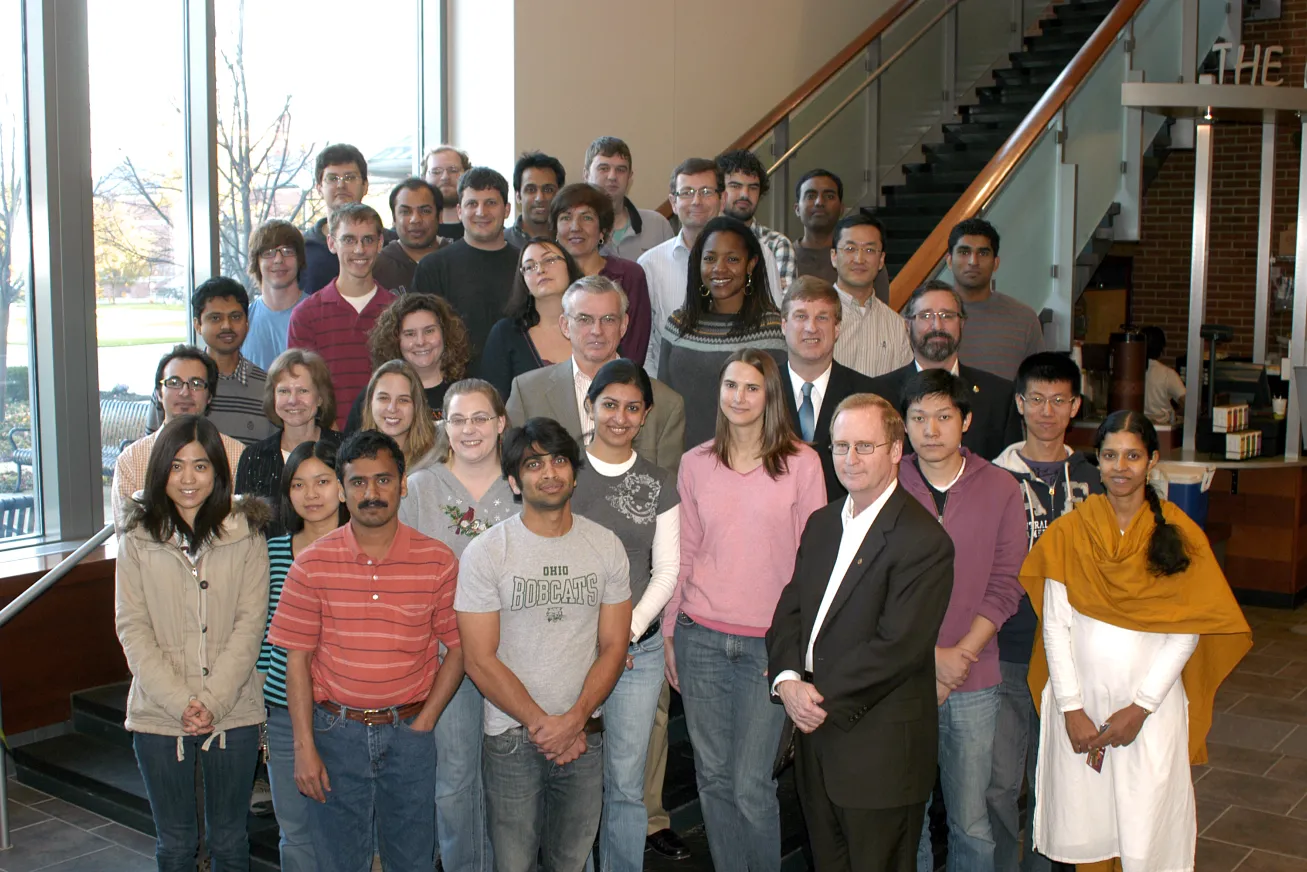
[650,216,787,446]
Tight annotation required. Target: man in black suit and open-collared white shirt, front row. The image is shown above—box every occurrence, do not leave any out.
[767,394,953,872]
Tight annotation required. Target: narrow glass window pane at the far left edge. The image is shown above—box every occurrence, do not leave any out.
[0,4,41,544]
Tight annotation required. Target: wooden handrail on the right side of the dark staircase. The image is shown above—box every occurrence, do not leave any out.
[890,0,1144,310]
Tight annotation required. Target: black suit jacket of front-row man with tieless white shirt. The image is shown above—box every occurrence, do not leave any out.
[767,488,953,808]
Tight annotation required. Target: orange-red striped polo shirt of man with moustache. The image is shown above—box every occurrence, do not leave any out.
[268,524,459,709]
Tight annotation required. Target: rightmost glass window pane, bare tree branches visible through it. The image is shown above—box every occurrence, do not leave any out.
[216,0,418,290]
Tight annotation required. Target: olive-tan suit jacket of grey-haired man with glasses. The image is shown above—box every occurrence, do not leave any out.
[507,358,690,473]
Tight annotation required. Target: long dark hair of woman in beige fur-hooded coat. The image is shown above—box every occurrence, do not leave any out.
[139,414,231,554]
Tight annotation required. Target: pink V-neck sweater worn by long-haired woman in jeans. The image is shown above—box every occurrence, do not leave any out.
[663,442,826,637]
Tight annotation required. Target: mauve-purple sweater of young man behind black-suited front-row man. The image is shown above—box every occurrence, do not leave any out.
[899,448,1027,693]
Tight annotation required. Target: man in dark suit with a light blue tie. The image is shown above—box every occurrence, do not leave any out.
[780,276,872,499]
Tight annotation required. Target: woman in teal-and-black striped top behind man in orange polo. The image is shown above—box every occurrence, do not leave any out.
[259,444,349,872]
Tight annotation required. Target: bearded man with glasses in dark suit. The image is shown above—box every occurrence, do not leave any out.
[872,281,1022,460]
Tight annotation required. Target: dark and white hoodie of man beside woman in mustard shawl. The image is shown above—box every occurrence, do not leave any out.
[993,442,1103,663]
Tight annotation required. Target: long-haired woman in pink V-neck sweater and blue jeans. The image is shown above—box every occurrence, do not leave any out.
[663,348,826,872]
